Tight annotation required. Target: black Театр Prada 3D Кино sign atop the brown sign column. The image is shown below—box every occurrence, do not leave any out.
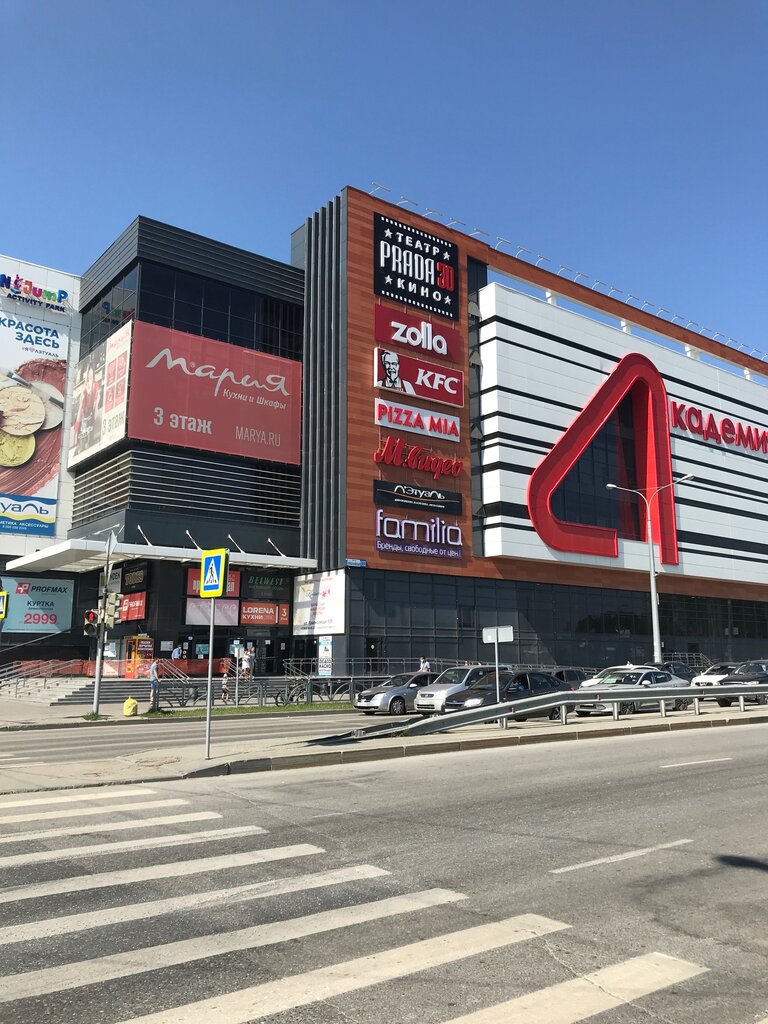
[374,213,459,319]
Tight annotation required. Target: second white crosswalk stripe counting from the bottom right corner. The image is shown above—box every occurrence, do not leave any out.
[107,913,570,1024]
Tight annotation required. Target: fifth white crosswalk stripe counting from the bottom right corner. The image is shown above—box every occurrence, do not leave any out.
[0,843,326,903]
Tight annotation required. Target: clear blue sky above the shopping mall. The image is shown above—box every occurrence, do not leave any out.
[6,0,768,350]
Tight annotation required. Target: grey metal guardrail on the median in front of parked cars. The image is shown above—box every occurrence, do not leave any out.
[352,685,768,739]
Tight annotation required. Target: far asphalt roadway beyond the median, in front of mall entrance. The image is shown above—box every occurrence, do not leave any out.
[0,712,382,768]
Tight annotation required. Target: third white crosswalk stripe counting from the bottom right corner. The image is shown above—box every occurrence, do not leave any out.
[0,889,466,1002]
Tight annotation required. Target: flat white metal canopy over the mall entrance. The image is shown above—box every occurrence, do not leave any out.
[4,538,317,572]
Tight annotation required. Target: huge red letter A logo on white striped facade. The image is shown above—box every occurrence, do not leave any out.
[528,352,678,565]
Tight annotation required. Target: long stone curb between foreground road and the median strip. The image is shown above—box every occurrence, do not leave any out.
[3,712,768,796]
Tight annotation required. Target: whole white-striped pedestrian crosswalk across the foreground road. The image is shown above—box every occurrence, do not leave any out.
[0,786,708,1024]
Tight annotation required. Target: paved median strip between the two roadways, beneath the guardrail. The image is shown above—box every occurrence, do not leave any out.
[0,706,768,794]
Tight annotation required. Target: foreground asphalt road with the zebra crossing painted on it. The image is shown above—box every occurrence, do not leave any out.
[0,726,768,1024]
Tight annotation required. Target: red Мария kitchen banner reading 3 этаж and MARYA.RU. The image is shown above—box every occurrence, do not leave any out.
[128,323,301,464]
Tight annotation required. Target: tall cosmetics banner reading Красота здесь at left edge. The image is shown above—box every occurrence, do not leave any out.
[0,292,70,537]
